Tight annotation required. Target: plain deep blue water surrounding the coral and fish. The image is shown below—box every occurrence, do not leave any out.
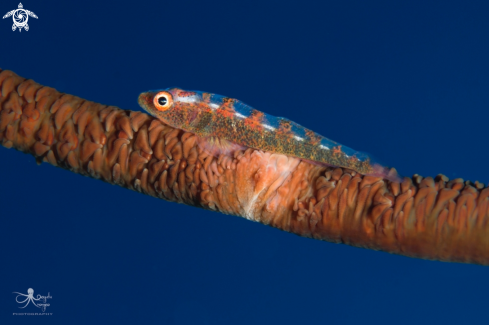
[0,0,489,325]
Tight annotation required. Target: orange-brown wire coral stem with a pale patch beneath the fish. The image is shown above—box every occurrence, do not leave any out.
[0,70,489,265]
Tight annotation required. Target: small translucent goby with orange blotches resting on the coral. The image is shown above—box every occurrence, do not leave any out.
[138,88,399,181]
